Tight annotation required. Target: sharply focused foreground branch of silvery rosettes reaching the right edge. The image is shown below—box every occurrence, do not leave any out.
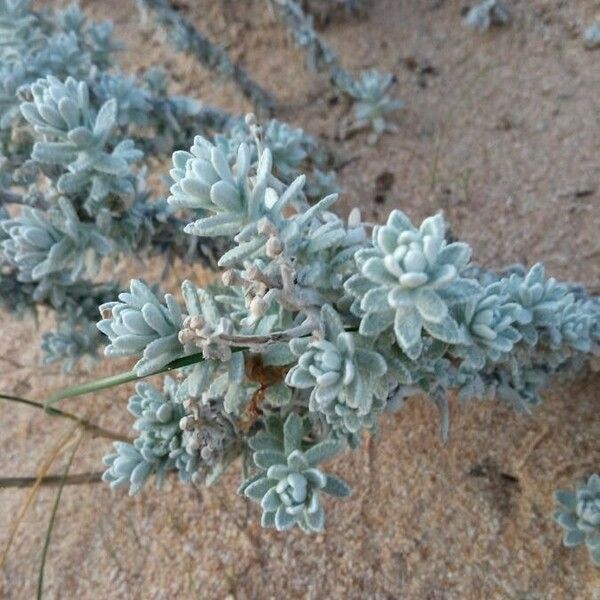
[85,115,600,531]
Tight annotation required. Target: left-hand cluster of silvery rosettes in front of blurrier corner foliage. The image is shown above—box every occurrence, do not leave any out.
[1,67,218,368]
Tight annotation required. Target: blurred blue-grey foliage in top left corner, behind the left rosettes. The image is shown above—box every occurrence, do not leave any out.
[0,0,234,185]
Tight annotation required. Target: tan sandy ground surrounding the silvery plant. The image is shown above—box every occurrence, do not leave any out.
[0,0,600,600]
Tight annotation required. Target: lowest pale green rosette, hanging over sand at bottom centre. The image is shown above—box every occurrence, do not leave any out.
[240,413,350,532]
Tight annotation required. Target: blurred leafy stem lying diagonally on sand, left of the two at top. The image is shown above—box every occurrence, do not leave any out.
[138,0,275,114]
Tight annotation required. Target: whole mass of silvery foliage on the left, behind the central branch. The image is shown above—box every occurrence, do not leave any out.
[0,2,241,369]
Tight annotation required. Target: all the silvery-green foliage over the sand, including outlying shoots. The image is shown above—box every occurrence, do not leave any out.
[0,0,600,548]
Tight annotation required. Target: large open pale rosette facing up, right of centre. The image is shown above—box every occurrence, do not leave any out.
[346,210,479,359]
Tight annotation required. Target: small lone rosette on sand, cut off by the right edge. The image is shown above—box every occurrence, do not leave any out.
[554,473,600,567]
